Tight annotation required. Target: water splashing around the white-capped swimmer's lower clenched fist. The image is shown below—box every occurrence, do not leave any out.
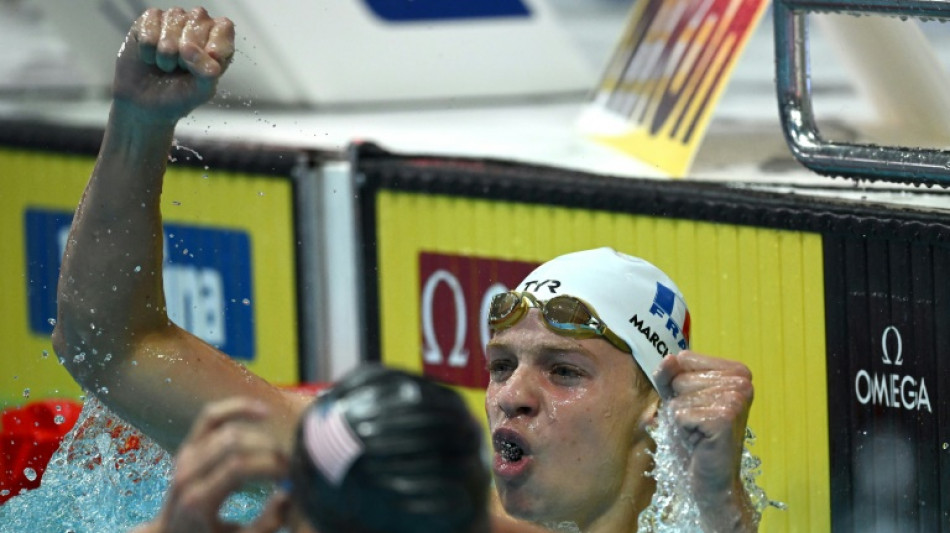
[637,406,787,533]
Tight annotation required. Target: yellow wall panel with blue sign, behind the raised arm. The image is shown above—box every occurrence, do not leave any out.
[0,147,299,406]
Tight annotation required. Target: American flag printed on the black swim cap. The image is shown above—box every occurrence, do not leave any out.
[303,403,364,486]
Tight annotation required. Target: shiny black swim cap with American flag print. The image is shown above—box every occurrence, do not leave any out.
[291,366,489,533]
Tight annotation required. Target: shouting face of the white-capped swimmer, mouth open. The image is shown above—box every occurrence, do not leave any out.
[485,309,656,529]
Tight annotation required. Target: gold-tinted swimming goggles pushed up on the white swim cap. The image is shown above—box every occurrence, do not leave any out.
[488,291,633,353]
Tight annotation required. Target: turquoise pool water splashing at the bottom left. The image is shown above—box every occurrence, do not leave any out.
[0,396,266,533]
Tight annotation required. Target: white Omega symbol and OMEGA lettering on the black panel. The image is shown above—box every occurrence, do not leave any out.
[854,326,933,413]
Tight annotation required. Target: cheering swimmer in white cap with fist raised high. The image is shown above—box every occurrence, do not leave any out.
[53,8,756,533]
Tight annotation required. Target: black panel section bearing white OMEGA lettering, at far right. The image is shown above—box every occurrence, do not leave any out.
[824,235,950,533]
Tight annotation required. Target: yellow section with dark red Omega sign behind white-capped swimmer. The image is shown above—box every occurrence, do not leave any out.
[375,190,830,531]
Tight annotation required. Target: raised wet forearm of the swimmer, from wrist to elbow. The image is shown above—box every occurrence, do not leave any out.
[54,104,174,364]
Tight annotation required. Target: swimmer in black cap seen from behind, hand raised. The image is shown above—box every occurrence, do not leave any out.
[134,365,548,533]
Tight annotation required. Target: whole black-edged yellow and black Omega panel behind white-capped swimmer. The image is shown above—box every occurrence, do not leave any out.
[356,146,950,531]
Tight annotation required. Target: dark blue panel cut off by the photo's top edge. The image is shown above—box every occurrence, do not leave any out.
[364,0,531,22]
